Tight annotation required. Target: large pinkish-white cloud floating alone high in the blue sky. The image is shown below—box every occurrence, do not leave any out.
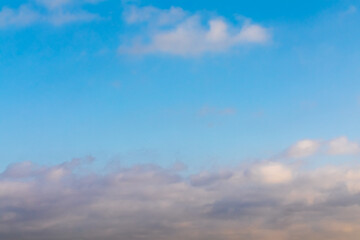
[119,7,271,56]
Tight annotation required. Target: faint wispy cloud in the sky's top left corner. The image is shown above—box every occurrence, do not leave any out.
[0,0,99,28]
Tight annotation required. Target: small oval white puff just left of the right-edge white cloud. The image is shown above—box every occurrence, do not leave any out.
[286,139,321,158]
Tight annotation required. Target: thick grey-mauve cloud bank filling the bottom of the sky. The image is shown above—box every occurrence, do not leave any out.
[0,157,360,240]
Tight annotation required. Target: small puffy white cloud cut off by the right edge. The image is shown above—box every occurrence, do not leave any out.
[328,137,360,155]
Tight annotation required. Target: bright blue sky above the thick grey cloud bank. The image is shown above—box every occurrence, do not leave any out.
[0,0,360,169]
